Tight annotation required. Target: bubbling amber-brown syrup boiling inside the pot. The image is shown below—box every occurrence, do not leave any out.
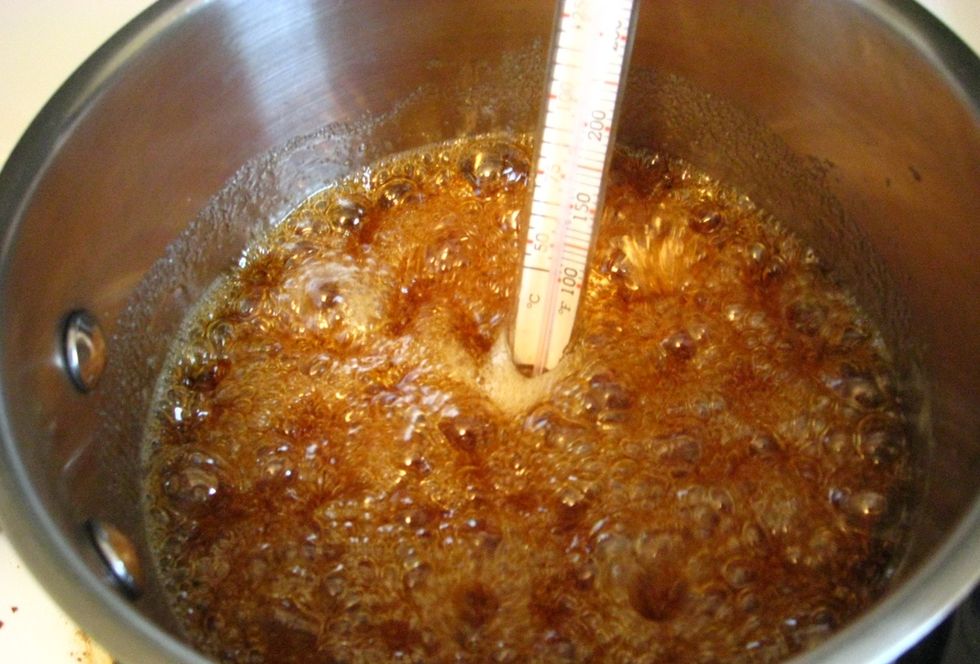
[146,137,908,662]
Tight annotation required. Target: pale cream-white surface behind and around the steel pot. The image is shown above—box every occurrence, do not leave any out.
[0,0,980,664]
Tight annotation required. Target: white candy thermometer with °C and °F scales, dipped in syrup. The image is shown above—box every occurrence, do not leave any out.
[513,0,635,374]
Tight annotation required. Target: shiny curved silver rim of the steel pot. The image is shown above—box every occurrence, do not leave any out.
[0,0,980,664]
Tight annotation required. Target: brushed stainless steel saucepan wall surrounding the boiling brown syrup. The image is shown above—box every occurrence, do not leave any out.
[0,0,980,663]
